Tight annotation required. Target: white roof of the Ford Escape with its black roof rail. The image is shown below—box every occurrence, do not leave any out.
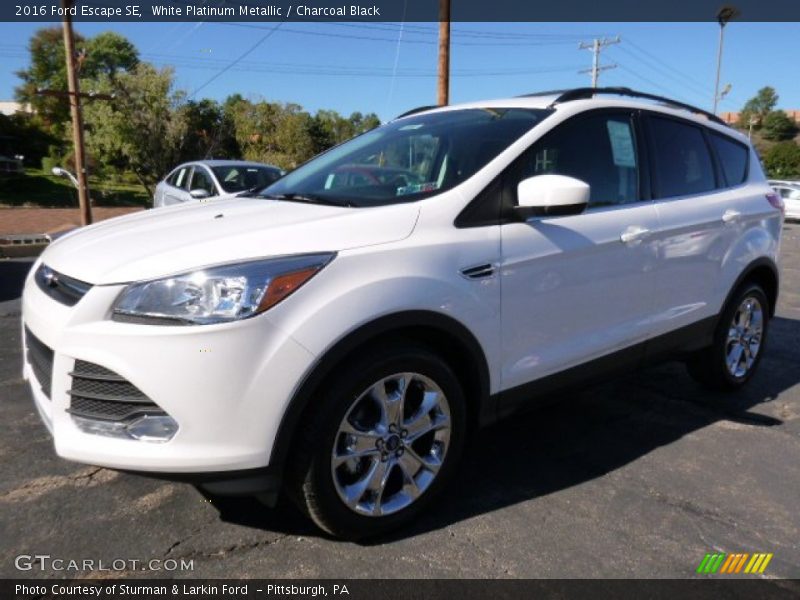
[398,88,750,146]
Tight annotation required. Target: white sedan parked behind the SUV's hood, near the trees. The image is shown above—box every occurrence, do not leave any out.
[153,160,284,208]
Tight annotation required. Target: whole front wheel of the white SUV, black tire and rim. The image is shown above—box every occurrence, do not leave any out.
[289,343,466,539]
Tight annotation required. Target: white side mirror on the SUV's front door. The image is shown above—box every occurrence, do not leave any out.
[517,175,590,219]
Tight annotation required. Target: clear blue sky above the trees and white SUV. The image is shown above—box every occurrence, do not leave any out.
[0,21,800,121]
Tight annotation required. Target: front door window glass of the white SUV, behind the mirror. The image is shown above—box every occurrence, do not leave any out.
[517,114,640,206]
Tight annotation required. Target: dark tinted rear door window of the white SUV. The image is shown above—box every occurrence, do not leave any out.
[650,117,716,198]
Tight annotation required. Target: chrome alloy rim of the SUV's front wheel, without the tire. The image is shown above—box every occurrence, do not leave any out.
[331,373,451,517]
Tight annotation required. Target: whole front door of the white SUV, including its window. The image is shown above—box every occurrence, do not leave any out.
[501,110,658,389]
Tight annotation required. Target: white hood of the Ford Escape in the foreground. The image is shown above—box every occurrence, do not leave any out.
[42,198,419,285]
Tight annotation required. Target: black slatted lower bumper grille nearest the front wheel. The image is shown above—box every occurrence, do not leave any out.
[68,360,166,421]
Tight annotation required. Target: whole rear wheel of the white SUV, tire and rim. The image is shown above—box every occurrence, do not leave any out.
[687,283,770,391]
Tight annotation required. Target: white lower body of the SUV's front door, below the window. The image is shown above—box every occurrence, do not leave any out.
[501,203,658,388]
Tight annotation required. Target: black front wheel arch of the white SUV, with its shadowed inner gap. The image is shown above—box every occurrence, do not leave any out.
[269,310,495,472]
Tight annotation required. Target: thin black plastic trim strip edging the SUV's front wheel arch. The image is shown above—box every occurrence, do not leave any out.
[269,310,495,473]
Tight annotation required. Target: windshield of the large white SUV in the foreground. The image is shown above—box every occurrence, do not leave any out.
[259,108,550,207]
